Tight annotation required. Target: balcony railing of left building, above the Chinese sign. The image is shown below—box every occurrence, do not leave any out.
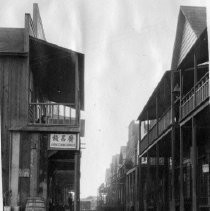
[28,103,79,126]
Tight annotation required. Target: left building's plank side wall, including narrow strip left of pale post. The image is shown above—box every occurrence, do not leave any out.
[0,56,28,195]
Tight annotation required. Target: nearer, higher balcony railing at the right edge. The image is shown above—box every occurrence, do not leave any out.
[180,73,209,119]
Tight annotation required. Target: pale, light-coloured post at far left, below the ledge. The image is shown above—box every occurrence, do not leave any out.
[10,132,20,206]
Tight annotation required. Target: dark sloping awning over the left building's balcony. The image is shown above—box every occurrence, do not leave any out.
[29,37,84,109]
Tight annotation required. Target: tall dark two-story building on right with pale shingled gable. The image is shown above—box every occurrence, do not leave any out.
[138,6,210,211]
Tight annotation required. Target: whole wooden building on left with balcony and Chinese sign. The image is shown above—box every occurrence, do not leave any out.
[0,4,84,211]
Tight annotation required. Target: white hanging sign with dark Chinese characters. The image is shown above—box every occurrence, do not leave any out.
[48,134,78,150]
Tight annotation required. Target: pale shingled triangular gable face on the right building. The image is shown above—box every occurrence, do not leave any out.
[178,20,197,65]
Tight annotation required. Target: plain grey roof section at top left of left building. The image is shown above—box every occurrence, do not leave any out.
[0,28,24,53]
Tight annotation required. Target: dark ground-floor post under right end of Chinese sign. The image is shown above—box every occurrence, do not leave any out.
[74,152,80,211]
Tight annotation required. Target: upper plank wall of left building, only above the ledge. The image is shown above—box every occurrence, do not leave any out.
[0,57,29,127]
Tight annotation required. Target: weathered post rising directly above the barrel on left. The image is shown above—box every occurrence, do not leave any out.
[30,133,40,197]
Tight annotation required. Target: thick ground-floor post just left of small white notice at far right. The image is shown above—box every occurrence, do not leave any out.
[191,117,198,211]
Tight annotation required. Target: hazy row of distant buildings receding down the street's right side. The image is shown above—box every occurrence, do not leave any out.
[98,121,139,211]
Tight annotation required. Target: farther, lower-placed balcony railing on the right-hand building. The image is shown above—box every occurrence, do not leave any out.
[140,107,172,154]
